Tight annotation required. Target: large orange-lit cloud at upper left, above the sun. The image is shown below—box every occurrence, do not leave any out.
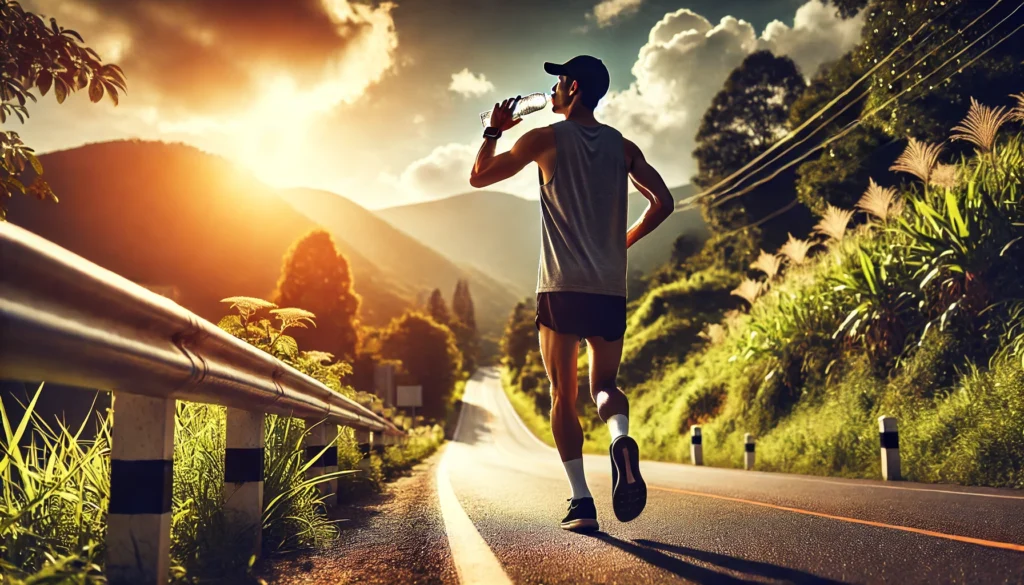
[27,0,397,117]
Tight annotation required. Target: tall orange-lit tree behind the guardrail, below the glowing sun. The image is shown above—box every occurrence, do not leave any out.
[273,229,360,360]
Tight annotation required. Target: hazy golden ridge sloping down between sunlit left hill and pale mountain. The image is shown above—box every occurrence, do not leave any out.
[281,189,522,333]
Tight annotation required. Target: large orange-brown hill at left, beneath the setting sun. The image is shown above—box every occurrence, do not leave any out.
[8,140,515,338]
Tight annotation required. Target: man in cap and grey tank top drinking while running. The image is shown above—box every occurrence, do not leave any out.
[469,55,674,531]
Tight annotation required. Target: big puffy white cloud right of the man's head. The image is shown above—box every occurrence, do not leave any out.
[598,0,863,185]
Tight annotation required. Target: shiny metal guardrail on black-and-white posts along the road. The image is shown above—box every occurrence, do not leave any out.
[0,222,404,584]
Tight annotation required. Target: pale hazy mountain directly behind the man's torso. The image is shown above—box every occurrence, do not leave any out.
[377,184,708,294]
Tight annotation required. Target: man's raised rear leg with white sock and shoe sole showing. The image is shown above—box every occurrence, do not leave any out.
[587,337,647,521]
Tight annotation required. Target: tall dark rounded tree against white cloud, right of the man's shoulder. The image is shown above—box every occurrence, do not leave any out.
[693,51,810,249]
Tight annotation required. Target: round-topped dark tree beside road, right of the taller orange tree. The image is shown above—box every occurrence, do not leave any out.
[381,311,462,419]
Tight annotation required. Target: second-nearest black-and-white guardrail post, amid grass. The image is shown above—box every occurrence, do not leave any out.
[224,408,265,554]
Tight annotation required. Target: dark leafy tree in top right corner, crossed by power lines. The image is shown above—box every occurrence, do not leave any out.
[791,0,1024,212]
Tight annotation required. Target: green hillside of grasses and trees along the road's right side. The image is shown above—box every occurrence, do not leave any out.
[503,0,1024,488]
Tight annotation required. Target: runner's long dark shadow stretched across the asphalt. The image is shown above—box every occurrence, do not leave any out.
[589,532,843,585]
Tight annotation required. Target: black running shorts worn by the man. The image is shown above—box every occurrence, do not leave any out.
[534,292,626,341]
